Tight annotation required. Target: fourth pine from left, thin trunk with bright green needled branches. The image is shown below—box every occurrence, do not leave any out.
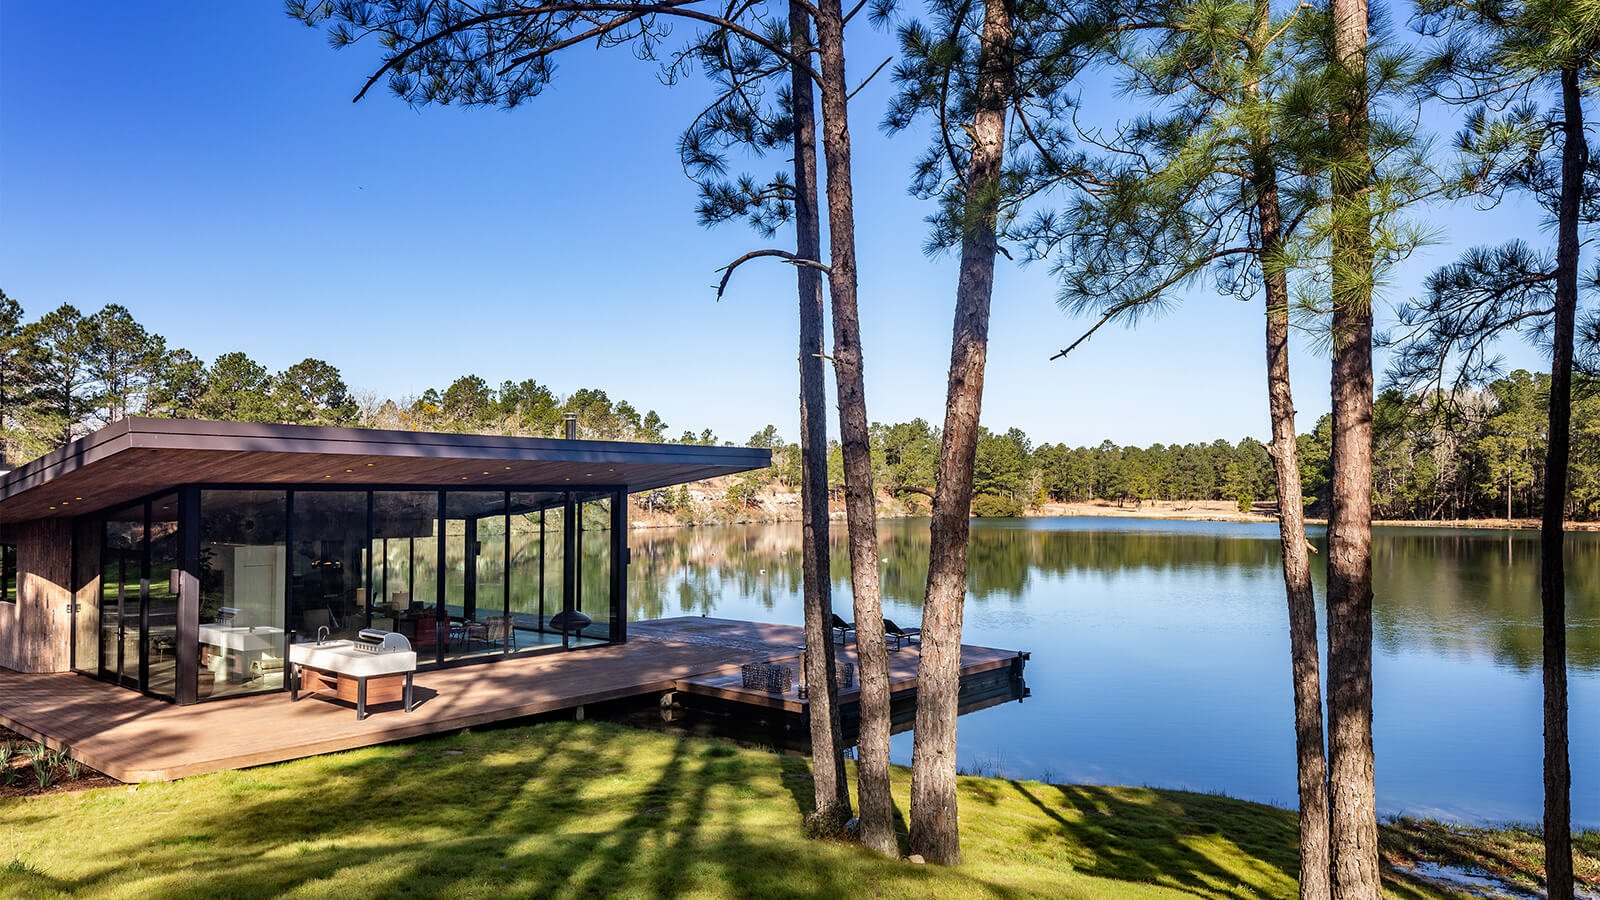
[1027,0,1406,897]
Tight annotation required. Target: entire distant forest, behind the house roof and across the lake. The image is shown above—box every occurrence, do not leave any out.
[0,291,1600,520]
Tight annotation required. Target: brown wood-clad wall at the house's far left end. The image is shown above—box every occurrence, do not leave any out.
[0,519,72,673]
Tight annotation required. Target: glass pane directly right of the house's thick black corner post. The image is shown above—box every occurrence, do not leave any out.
[195,490,288,700]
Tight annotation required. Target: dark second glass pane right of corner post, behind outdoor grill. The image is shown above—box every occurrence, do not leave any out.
[290,490,368,641]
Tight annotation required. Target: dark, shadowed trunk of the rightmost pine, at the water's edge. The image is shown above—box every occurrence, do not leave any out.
[1539,69,1589,900]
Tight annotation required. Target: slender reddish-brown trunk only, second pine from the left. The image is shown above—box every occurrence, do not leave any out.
[816,0,899,855]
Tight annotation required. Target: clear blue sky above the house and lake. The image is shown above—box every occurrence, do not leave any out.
[0,0,1538,444]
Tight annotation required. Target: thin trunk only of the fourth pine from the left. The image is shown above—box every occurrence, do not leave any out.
[1246,0,1331,900]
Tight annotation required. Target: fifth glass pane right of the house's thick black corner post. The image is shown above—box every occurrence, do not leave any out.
[509,492,566,650]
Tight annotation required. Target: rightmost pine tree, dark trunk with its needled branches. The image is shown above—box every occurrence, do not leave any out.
[1394,0,1600,883]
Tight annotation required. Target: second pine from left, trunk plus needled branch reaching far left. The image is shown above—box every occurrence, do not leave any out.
[297,0,898,854]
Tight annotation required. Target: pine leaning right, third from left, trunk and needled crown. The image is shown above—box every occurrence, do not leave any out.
[885,0,1077,863]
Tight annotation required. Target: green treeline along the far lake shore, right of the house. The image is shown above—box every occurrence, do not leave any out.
[736,370,1600,520]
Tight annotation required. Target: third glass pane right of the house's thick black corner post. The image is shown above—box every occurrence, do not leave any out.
[373,490,448,663]
